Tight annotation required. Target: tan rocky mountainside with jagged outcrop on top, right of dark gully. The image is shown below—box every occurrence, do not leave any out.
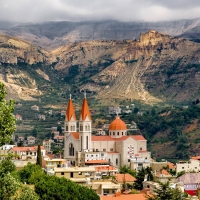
[52,30,200,102]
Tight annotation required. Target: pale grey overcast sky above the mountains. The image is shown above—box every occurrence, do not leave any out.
[0,0,200,22]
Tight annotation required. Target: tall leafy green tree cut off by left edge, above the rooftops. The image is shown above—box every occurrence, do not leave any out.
[0,82,16,145]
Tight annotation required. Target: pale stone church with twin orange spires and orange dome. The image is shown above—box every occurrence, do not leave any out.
[64,95,150,170]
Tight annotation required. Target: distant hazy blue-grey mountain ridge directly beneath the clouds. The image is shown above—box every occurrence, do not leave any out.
[0,18,200,50]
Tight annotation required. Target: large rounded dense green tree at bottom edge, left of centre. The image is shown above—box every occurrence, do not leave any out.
[35,175,100,200]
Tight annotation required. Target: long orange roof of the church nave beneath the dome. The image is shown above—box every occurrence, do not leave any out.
[92,135,146,141]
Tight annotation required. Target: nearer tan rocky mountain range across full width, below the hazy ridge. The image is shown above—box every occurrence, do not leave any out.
[0,30,200,103]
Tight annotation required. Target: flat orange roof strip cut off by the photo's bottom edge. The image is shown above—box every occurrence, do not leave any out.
[101,194,146,200]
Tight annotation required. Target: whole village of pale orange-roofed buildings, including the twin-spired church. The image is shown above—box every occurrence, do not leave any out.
[0,94,200,200]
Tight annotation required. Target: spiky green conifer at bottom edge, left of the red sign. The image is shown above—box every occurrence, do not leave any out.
[146,181,183,200]
